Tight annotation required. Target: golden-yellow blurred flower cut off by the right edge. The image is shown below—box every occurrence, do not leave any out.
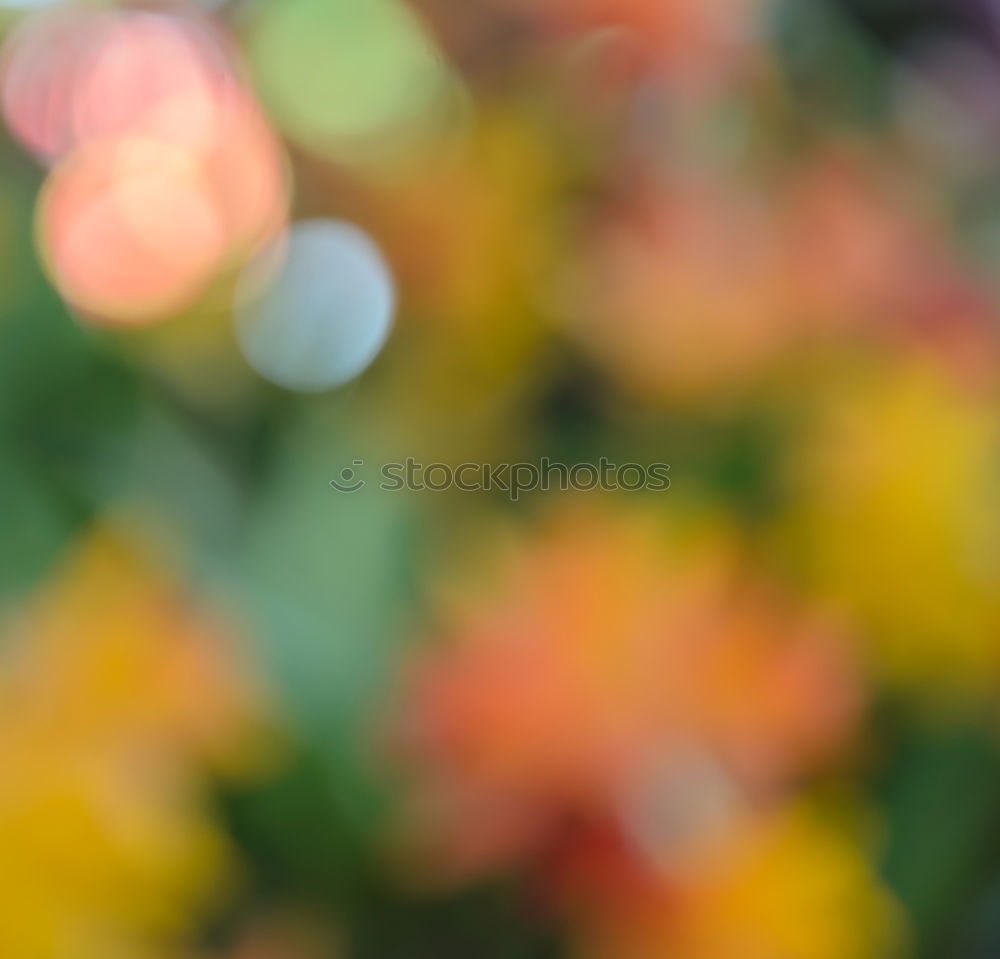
[786,358,1000,690]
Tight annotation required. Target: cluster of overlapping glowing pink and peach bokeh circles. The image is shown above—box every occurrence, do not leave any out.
[4,3,286,325]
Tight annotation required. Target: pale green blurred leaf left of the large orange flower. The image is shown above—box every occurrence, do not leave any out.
[224,398,412,818]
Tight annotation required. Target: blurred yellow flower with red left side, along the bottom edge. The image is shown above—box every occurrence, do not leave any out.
[570,803,903,959]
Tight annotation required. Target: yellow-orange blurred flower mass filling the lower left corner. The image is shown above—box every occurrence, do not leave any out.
[0,531,262,959]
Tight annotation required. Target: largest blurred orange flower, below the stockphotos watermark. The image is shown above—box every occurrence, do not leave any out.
[396,513,859,871]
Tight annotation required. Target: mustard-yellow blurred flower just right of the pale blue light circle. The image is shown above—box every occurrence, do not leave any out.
[379,105,558,348]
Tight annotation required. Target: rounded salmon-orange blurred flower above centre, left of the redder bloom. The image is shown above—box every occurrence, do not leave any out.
[567,171,794,398]
